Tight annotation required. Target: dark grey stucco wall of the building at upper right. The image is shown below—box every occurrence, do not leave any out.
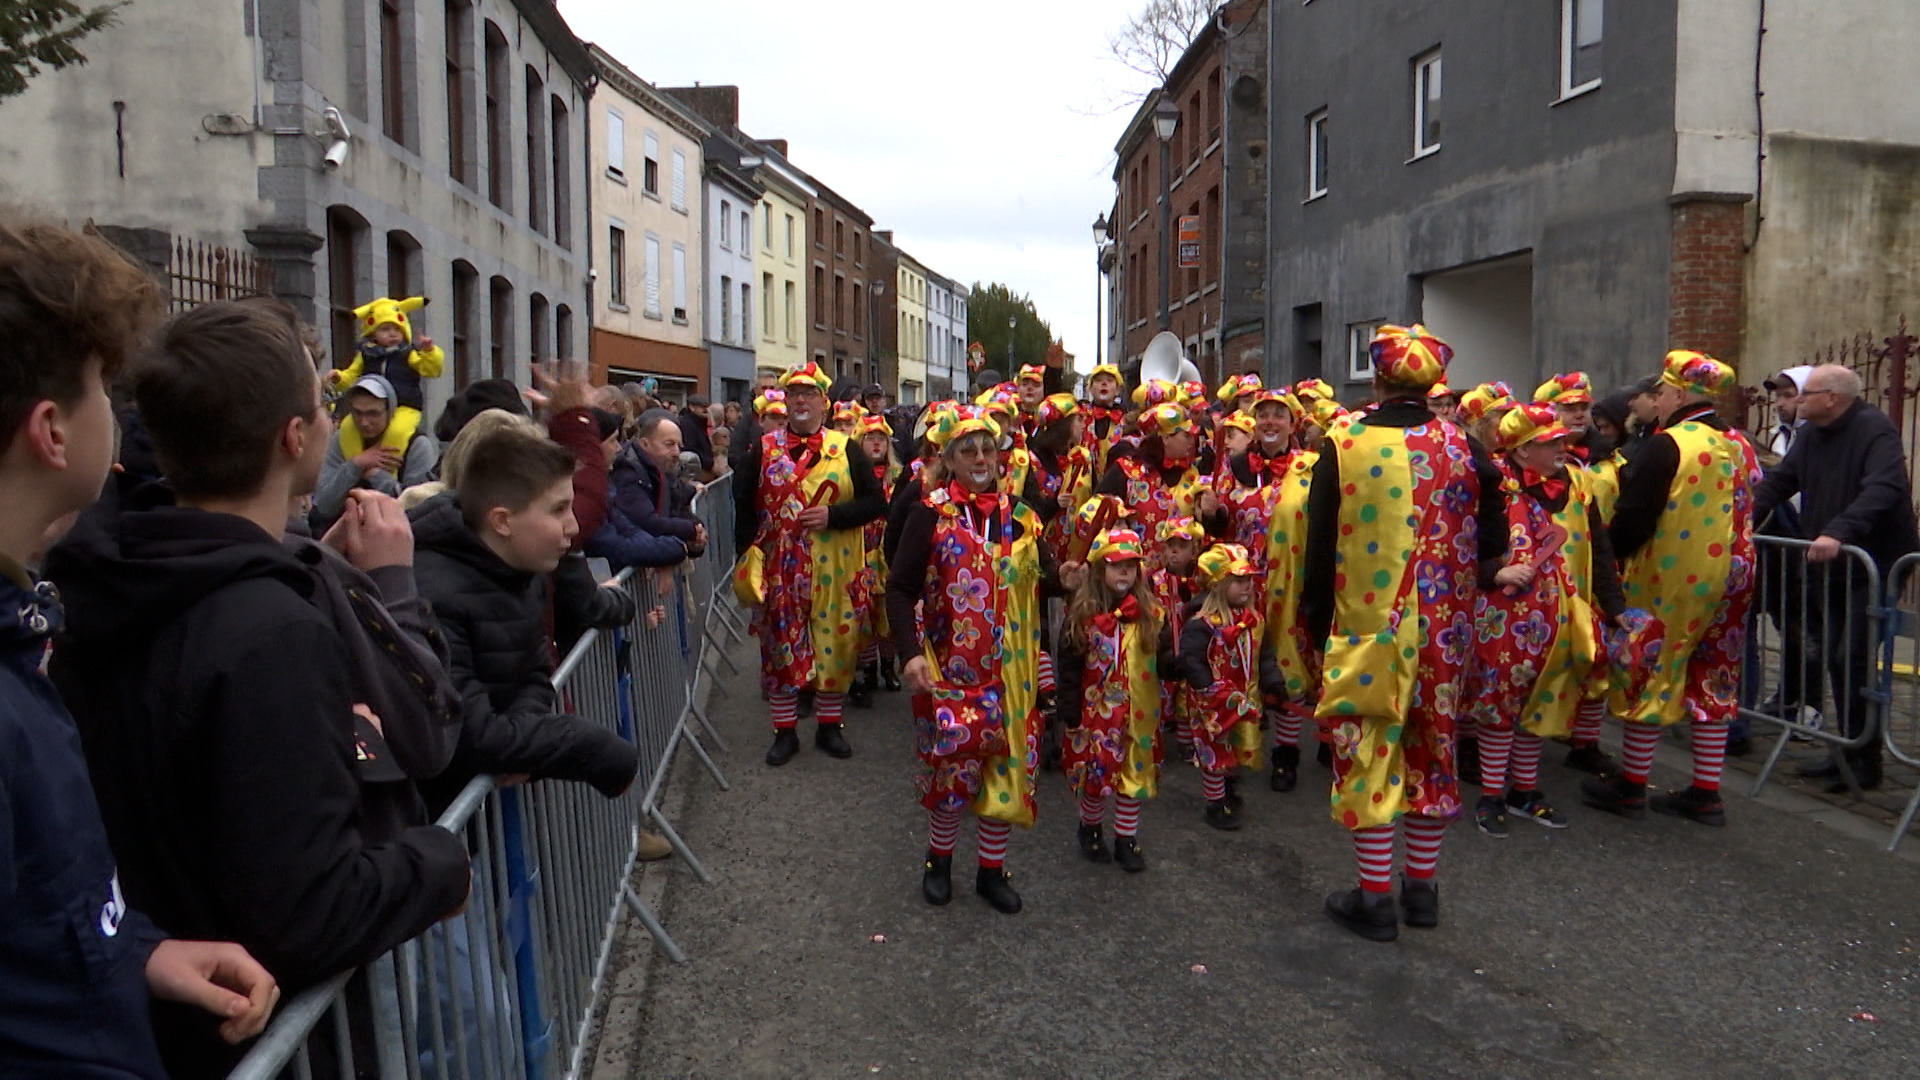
[1267,0,1674,390]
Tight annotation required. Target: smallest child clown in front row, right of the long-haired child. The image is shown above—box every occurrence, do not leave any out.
[1179,544,1279,832]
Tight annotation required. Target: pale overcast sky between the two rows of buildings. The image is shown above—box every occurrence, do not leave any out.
[561,0,1142,369]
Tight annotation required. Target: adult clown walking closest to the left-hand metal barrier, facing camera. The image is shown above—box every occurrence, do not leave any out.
[733,361,887,767]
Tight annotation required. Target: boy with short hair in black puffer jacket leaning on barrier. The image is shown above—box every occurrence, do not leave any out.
[409,429,639,805]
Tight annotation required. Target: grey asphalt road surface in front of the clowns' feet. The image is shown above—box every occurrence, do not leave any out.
[622,642,1920,1078]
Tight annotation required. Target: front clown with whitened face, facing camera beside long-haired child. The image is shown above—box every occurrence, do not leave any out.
[887,407,1077,915]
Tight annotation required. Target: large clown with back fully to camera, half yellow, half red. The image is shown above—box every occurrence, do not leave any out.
[1302,325,1505,942]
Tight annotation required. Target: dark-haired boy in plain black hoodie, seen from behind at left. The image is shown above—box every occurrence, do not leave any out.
[46,302,468,1076]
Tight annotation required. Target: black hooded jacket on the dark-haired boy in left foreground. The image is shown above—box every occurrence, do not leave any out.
[46,484,468,1076]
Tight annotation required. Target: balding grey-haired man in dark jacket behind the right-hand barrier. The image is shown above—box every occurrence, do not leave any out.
[1753,363,1920,794]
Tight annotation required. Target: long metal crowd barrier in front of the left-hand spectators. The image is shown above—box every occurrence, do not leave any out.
[228,479,743,1080]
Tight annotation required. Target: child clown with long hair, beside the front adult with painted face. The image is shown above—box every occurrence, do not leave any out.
[1060,528,1171,872]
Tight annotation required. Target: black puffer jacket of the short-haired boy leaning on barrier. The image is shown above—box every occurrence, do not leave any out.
[407,494,639,809]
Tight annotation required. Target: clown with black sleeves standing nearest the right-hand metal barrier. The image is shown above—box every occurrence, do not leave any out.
[1580,350,1761,824]
